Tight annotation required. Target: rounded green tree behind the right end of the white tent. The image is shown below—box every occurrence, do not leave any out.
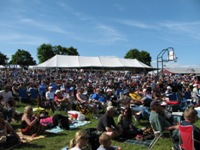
[124,49,151,66]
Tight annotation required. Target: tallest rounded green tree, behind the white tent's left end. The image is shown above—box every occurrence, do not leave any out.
[37,43,55,63]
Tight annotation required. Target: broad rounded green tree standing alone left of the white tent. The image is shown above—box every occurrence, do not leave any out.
[9,49,36,67]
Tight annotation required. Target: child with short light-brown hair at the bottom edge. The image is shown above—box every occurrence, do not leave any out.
[97,133,122,150]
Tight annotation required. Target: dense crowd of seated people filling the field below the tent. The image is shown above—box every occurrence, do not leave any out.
[0,69,200,150]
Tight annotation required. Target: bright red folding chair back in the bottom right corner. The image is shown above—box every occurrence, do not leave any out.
[179,125,195,150]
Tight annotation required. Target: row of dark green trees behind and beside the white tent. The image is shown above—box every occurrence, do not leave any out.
[0,43,151,67]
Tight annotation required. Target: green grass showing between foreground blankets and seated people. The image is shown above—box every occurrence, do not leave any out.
[12,103,191,150]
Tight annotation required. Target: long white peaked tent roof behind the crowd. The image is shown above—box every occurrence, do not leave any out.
[34,55,153,69]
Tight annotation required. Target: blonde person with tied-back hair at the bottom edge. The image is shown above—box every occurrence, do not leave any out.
[69,130,91,150]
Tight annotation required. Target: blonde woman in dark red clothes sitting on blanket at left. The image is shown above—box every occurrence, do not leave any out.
[21,106,45,137]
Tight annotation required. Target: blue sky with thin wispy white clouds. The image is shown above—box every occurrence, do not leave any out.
[0,0,200,67]
